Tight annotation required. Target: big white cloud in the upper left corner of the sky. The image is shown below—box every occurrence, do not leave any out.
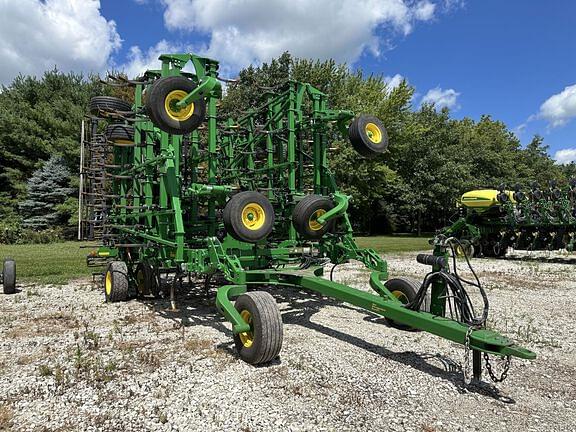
[0,0,121,84]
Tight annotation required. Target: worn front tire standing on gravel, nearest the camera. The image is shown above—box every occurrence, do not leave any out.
[234,291,283,364]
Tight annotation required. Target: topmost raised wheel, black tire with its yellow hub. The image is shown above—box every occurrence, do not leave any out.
[146,76,206,135]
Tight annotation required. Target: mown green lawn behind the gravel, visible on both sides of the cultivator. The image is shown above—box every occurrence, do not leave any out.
[0,236,430,284]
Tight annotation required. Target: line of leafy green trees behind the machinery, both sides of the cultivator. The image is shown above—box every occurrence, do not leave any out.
[0,53,576,242]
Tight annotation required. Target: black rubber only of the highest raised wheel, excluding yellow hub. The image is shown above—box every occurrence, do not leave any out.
[146,76,206,135]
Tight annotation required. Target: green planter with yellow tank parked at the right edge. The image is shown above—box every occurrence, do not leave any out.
[441,180,576,257]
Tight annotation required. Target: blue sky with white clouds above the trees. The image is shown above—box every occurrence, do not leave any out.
[0,0,576,162]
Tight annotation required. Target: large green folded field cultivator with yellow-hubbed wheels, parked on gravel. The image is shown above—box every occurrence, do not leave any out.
[80,54,535,378]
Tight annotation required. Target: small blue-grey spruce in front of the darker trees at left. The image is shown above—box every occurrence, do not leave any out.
[19,156,73,231]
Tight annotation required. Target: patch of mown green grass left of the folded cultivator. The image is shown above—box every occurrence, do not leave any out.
[0,242,92,285]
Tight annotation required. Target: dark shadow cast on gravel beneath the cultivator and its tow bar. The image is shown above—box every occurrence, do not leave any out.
[140,276,516,404]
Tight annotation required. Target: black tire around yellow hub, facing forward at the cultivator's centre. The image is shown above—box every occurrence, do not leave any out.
[222,191,274,243]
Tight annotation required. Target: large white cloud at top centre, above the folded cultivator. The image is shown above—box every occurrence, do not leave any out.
[156,0,436,70]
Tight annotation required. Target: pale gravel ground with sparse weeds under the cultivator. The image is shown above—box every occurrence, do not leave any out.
[0,253,576,432]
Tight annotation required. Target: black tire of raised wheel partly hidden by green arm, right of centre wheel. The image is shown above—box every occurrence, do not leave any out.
[292,195,336,240]
